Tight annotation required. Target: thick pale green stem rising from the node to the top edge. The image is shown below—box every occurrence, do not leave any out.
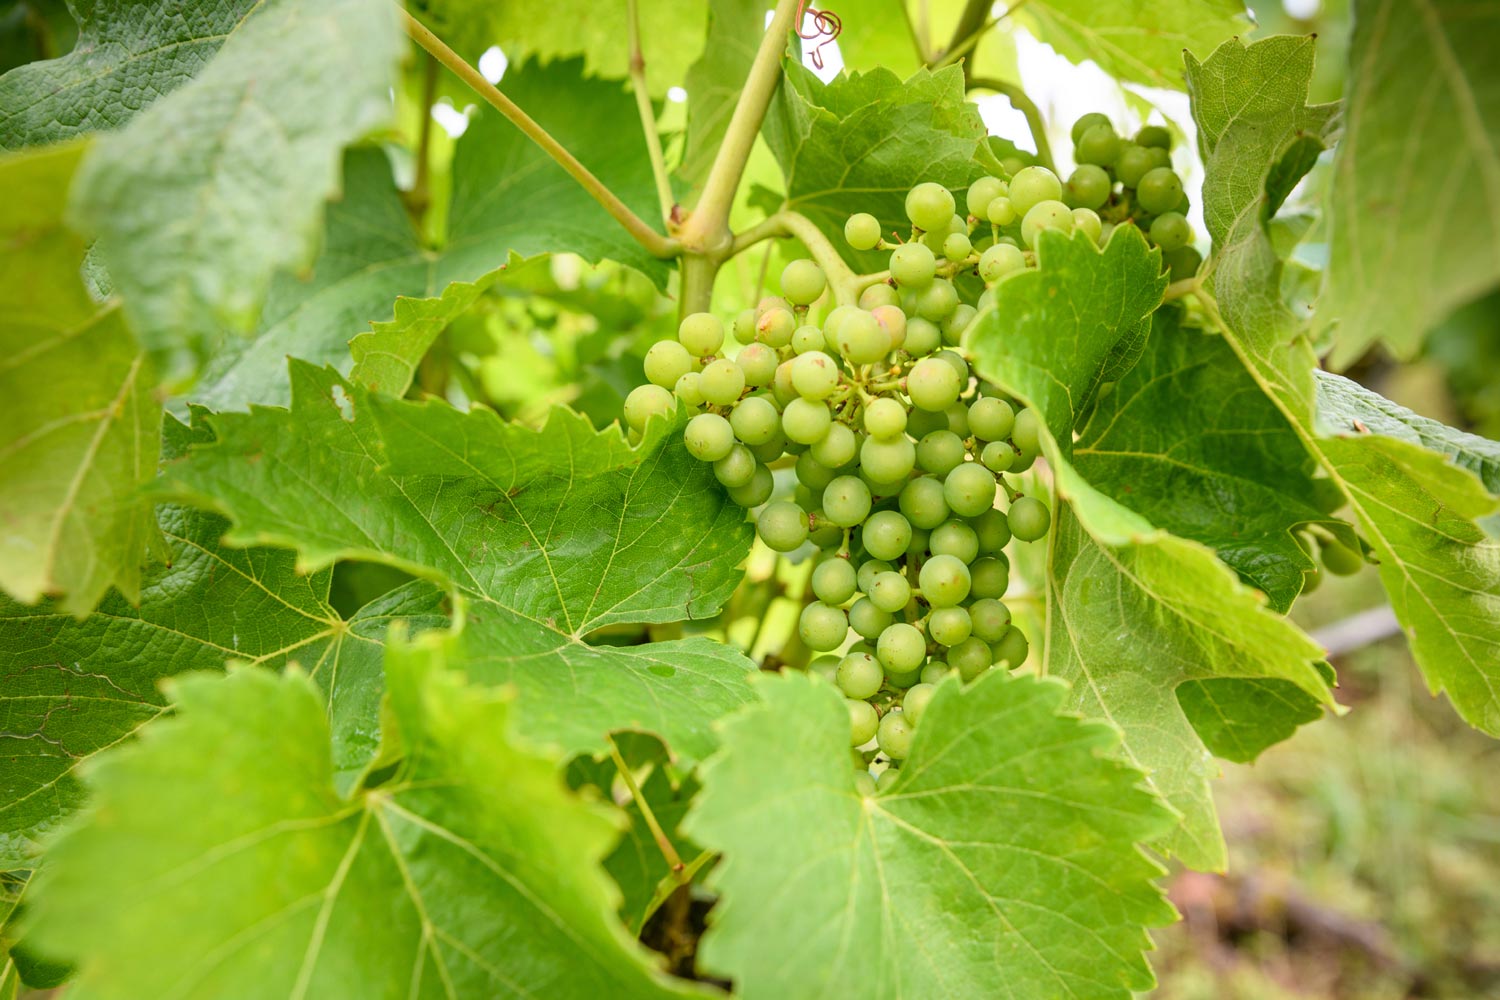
[678,0,798,252]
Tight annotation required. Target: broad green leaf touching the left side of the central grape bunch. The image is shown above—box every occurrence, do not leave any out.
[158,361,753,759]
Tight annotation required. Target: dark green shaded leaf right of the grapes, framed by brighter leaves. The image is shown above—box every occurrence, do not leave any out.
[1073,309,1353,612]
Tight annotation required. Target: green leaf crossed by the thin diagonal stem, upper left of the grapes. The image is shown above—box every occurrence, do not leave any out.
[194,60,668,409]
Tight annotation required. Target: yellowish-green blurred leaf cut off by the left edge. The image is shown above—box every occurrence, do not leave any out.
[0,144,162,615]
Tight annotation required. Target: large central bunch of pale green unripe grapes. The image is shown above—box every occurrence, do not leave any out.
[626,171,1074,789]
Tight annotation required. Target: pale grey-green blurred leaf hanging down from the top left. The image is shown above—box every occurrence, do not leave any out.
[74,0,405,348]
